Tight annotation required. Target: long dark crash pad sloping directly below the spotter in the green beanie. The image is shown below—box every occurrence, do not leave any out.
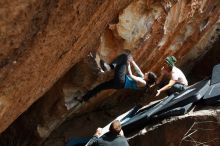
[122,80,210,135]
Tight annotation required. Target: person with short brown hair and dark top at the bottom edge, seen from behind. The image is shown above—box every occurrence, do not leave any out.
[87,120,129,146]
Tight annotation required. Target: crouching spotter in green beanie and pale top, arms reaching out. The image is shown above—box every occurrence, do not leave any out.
[156,56,188,96]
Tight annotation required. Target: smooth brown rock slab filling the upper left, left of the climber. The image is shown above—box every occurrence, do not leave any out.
[0,0,130,132]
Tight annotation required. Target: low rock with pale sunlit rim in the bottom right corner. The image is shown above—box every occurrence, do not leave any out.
[129,107,220,146]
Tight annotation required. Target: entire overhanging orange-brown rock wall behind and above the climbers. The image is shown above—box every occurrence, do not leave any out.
[0,0,220,145]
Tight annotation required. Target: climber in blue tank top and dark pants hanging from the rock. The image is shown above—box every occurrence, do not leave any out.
[75,52,157,102]
